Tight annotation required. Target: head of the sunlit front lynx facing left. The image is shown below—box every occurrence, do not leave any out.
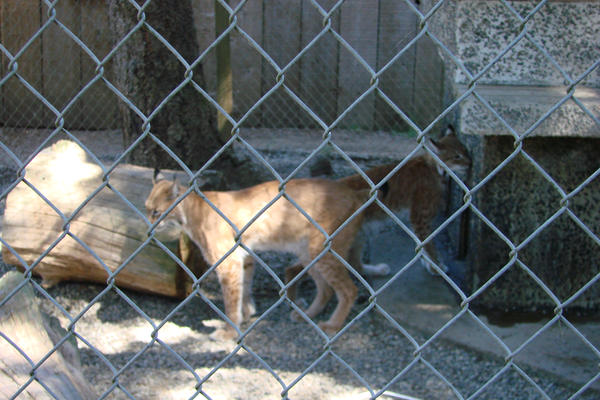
[145,169,185,238]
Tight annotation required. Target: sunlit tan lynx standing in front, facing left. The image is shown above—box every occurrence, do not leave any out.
[145,171,369,338]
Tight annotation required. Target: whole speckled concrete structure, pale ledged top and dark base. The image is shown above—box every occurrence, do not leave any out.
[423,0,600,312]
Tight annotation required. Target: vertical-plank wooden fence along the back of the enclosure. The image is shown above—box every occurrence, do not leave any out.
[0,0,444,130]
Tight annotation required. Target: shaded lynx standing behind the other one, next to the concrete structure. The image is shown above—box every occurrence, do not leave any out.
[285,126,471,300]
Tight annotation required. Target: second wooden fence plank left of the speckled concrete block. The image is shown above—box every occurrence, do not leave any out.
[375,0,417,131]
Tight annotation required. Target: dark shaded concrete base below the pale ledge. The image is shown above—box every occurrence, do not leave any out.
[468,136,600,312]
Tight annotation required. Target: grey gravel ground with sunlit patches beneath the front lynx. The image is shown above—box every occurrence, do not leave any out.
[0,129,598,399]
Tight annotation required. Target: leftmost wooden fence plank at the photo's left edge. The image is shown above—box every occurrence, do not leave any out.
[0,0,48,128]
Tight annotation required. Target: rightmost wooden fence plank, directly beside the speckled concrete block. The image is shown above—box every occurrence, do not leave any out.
[414,37,444,127]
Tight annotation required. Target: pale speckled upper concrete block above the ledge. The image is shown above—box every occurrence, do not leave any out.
[425,0,600,87]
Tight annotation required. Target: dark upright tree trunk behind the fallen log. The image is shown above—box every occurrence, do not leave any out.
[109,0,231,169]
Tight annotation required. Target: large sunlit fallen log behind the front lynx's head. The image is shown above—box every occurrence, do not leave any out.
[2,140,211,297]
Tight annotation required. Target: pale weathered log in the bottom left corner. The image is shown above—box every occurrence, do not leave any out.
[0,271,97,400]
